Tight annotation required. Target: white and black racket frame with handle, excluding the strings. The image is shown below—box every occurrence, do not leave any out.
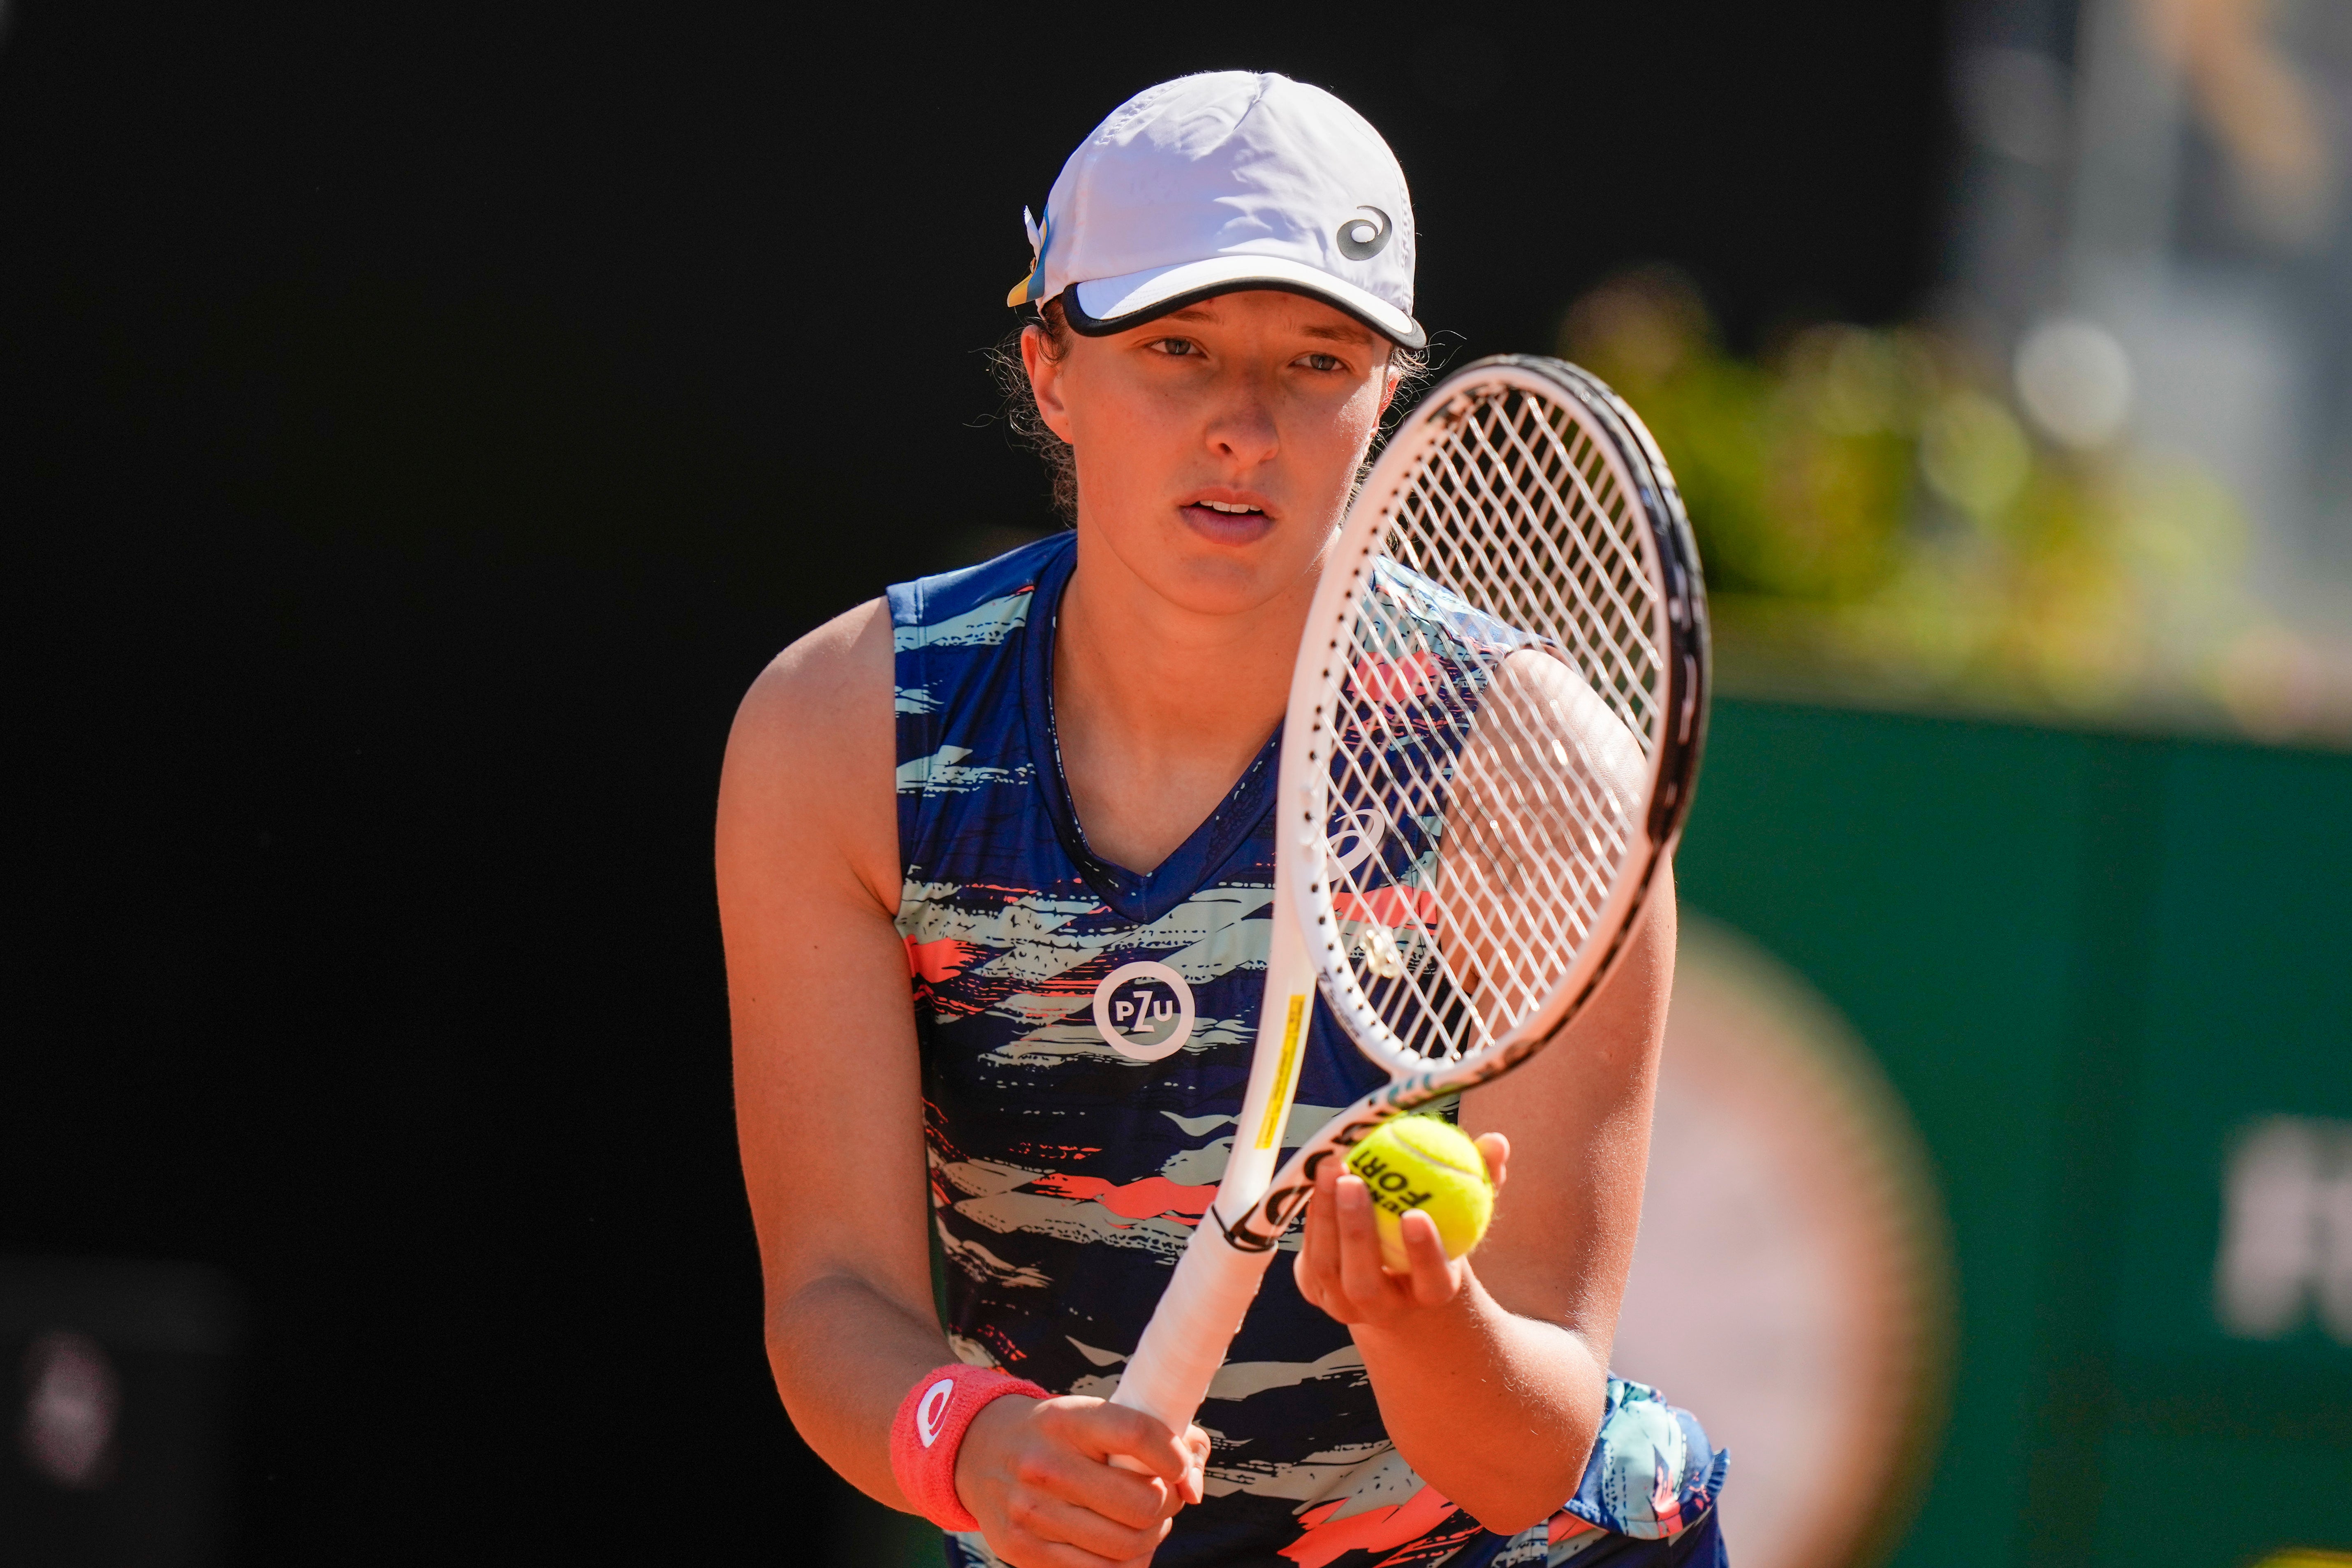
[1113,355,1708,1431]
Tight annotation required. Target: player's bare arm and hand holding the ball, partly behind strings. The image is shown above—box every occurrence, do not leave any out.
[1298,656,1675,1531]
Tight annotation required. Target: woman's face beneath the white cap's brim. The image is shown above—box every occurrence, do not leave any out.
[1021,289,1395,614]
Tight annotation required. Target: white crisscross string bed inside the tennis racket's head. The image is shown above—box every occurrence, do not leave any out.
[1324,390,1663,1065]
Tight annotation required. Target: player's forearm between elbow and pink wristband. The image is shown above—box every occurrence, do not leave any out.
[767,1274,955,1512]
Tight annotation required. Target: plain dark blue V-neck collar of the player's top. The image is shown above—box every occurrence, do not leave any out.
[1021,534,1282,924]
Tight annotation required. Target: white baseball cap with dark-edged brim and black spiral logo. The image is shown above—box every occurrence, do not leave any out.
[1004,70,1428,348]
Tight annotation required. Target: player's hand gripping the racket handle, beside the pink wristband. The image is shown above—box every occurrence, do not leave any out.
[955,1394,1209,1568]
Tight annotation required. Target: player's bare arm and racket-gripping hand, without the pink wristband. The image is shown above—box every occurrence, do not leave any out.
[718,602,1202,1568]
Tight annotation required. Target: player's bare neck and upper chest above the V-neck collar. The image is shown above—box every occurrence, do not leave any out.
[1054,531,1315,872]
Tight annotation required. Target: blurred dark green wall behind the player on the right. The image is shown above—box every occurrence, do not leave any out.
[1679,701,2352,1568]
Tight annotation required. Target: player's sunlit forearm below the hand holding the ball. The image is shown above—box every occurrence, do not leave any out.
[1355,1274,1609,1531]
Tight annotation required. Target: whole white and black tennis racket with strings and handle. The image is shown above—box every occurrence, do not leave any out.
[1113,355,1708,1431]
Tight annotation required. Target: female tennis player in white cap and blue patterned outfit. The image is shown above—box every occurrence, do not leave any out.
[718,73,1724,1568]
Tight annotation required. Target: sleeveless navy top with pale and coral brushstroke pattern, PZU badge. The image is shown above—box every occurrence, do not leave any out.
[889,534,1722,1568]
